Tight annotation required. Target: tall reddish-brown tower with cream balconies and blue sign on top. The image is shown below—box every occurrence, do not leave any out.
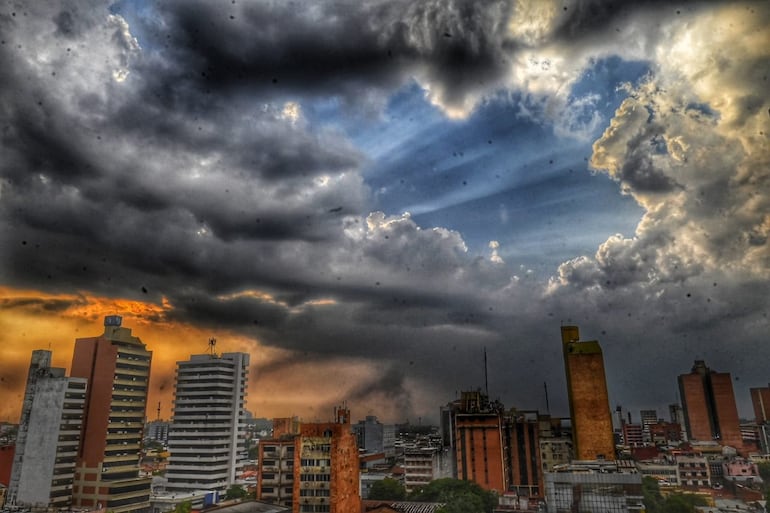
[71,315,152,513]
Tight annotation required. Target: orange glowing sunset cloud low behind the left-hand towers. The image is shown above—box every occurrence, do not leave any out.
[0,287,384,423]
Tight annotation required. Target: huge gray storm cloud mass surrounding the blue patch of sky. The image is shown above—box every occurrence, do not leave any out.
[0,1,770,420]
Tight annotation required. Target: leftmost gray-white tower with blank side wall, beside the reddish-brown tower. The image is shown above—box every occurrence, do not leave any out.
[7,350,87,509]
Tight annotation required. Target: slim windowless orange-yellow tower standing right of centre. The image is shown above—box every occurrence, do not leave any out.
[561,326,615,460]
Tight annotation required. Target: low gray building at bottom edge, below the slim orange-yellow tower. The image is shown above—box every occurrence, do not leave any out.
[545,461,644,513]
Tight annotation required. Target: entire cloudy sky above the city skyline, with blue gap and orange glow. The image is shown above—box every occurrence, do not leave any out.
[0,0,770,423]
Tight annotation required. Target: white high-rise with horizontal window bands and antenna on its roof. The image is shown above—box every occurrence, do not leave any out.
[166,352,249,492]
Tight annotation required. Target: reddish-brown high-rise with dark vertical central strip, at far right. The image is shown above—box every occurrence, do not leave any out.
[678,360,742,448]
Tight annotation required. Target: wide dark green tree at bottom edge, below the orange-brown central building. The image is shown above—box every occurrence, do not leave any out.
[409,478,497,513]
